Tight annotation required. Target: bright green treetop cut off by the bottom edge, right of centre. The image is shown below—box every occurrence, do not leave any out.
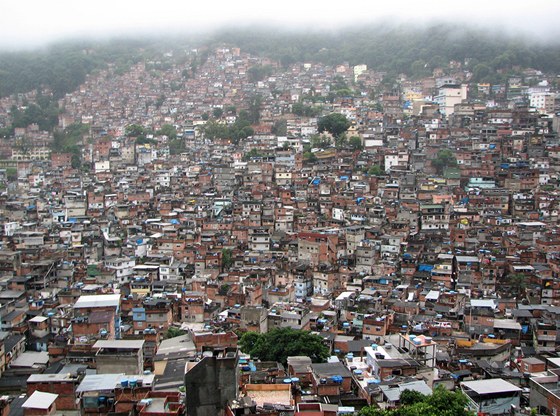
[358,386,474,416]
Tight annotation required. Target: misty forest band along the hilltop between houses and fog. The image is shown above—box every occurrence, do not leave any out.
[0,25,560,97]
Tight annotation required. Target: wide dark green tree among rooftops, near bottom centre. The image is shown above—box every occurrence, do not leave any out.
[239,328,330,365]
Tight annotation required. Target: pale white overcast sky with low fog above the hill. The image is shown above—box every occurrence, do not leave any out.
[0,0,560,49]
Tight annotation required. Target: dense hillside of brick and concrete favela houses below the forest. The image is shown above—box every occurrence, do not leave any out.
[0,46,560,416]
